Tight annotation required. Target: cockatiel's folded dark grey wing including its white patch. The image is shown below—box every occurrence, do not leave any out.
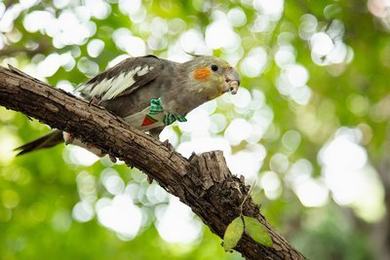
[77,55,163,102]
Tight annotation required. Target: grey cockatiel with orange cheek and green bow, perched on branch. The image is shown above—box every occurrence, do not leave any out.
[16,55,240,156]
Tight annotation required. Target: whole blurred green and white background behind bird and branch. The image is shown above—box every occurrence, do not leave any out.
[0,0,390,259]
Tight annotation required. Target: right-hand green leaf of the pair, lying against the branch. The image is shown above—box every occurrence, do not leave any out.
[244,216,272,246]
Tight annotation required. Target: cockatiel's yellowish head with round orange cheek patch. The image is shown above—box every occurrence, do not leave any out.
[186,56,240,100]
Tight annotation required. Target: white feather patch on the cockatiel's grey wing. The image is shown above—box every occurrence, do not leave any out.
[78,65,153,101]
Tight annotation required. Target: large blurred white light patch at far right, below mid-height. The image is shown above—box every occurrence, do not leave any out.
[318,128,384,221]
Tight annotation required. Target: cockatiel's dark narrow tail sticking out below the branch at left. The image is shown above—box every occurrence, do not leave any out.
[15,130,64,156]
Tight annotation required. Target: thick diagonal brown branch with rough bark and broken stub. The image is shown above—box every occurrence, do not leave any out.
[0,68,304,259]
